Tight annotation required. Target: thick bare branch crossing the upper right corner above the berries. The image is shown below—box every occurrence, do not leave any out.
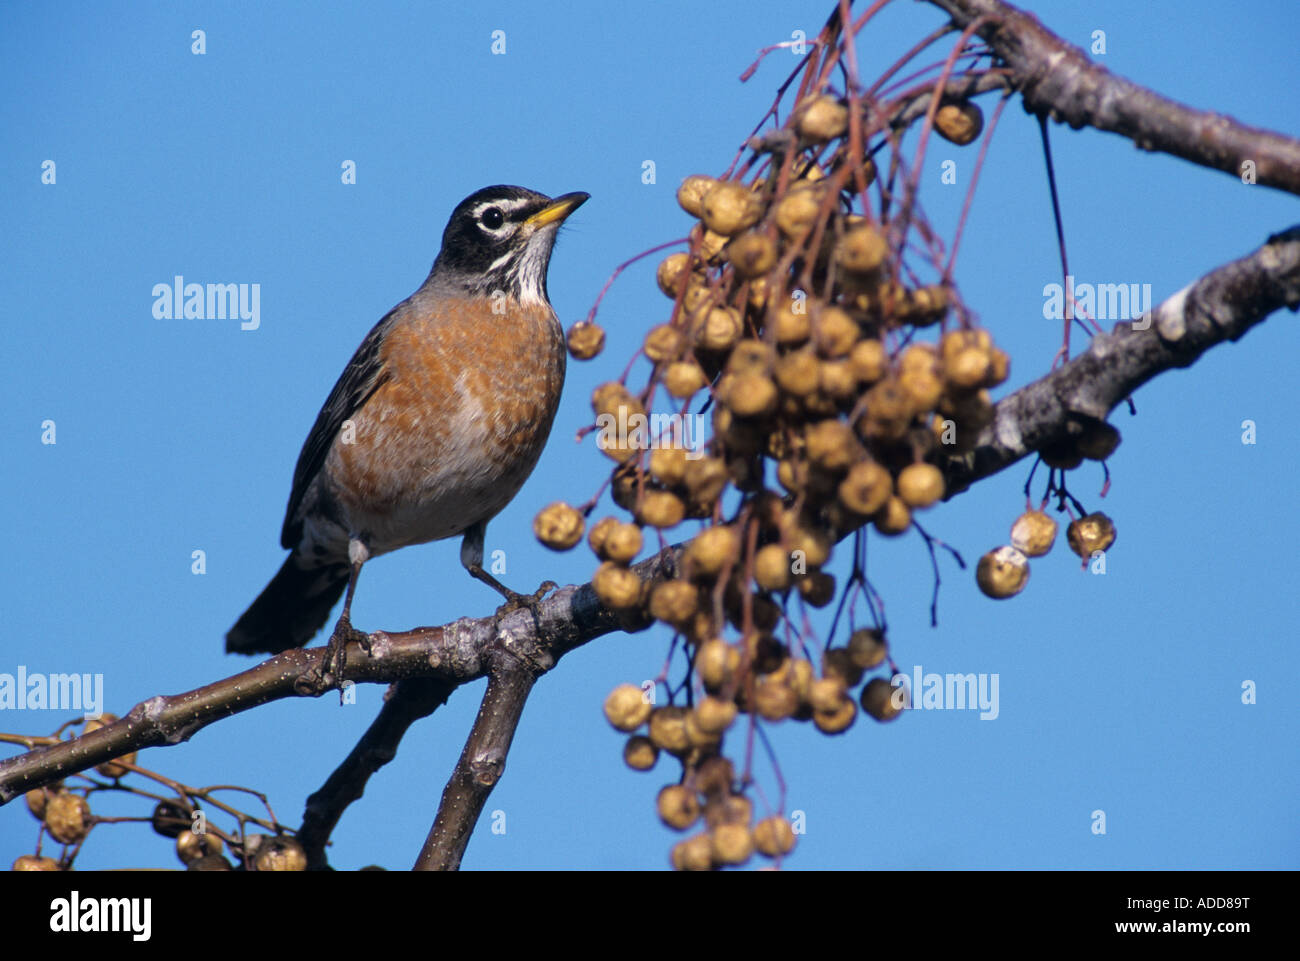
[928,0,1300,194]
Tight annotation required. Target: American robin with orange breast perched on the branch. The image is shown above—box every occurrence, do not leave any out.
[226,186,589,655]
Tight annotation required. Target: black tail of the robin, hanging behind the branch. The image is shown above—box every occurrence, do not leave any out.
[226,554,347,654]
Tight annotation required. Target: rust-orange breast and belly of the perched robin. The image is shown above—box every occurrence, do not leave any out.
[325,291,564,554]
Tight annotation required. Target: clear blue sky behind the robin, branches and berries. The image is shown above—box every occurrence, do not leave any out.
[0,0,1300,869]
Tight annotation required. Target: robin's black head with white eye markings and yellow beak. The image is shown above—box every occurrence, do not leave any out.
[429,185,590,303]
